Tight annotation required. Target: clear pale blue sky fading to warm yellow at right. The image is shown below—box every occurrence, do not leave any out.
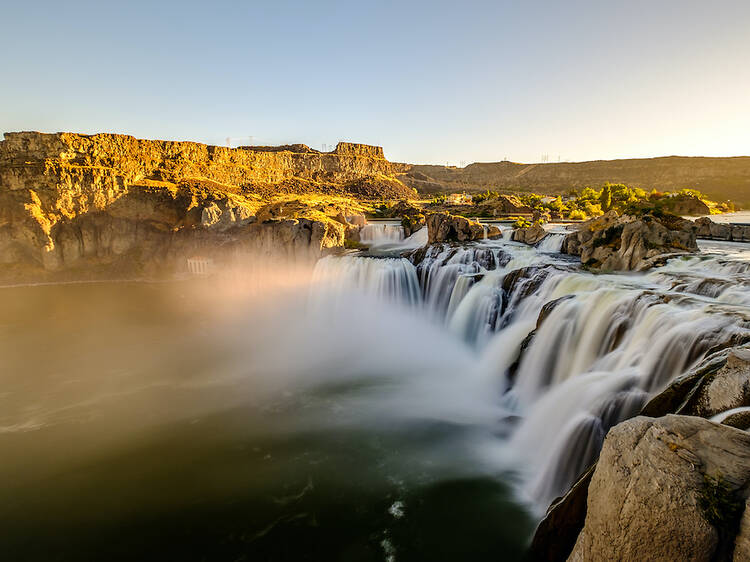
[0,0,750,164]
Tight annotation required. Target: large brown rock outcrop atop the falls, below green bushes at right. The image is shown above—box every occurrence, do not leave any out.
[562,211,698,271]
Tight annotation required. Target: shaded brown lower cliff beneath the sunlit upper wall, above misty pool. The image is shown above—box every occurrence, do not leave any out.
[0,184,346,279]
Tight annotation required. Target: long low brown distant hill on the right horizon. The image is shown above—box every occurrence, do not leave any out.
[401,156,750,205]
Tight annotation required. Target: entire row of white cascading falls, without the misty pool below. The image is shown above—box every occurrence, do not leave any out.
[308,228,750,513]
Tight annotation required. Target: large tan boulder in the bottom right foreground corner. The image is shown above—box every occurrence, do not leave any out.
[569,415,750,562]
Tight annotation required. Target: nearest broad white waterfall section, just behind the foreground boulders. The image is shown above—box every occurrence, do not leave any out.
[506,287,748,507]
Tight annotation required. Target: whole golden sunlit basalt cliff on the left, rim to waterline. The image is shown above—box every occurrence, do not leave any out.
[0,132,416,278]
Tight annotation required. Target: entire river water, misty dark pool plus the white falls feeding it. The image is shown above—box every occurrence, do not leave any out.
[0,223,750,561]
